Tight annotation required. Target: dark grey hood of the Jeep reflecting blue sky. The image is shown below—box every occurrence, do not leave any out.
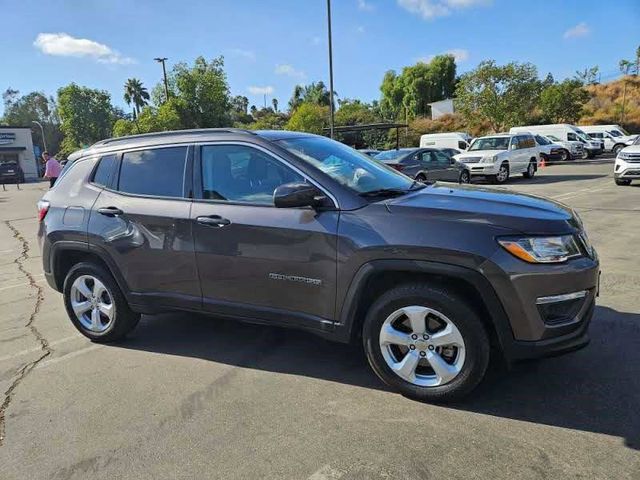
[386,183,582,235]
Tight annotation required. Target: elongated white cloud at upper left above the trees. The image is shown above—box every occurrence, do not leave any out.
[33,33,135,65]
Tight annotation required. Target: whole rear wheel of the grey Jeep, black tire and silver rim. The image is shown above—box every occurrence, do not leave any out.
[63,262,140,343]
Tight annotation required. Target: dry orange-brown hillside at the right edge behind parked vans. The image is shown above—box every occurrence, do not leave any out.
[578,75,640,133]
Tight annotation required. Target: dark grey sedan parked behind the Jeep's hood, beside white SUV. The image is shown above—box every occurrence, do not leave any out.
[374,148,471,183]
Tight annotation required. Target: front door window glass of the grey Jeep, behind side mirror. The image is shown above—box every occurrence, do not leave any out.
[201,145,305,205]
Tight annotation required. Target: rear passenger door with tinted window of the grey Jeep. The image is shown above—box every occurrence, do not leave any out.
[89,145,201,308]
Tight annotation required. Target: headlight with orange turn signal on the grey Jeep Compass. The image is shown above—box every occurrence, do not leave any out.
[498,235,581,263]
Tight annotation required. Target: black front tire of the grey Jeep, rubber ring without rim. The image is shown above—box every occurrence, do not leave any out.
[362,286,489,402]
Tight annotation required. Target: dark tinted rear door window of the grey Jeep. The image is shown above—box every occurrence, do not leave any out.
[118,147,187,197]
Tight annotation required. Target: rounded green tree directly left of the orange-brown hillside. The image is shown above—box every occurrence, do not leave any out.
[539,79,590,123]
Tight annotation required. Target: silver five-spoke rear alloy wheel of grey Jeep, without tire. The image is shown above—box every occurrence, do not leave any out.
[71,275,115,333]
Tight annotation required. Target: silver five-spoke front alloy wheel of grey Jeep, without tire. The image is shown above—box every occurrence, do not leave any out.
[379,305,465,387]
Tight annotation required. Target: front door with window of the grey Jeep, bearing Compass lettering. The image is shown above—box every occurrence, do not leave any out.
[191,143,339,326]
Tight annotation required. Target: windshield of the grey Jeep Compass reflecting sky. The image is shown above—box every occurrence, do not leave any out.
[278,137,413,193]
